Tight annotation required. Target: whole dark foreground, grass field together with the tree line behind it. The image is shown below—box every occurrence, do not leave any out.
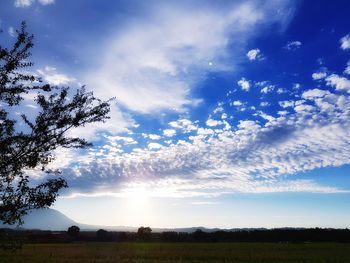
[0,226,350,263]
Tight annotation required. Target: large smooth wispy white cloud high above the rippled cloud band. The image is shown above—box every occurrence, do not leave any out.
[86,1,291,113]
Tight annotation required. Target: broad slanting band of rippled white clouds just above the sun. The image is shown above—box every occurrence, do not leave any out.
[50,85,350,197]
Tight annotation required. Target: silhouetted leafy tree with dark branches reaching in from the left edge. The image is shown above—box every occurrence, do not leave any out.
[0,22,110,227]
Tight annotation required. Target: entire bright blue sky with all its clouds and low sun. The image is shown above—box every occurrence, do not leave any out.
[0,0,350,228]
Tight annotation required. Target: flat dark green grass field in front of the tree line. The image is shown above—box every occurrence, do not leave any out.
[0,243,350,263]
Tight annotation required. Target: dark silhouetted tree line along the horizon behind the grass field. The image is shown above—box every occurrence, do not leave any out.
[0,226,350,243]
